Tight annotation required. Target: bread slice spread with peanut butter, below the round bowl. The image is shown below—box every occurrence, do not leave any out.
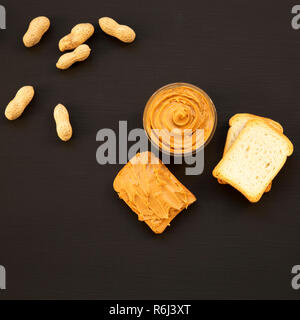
[114,152,196,233]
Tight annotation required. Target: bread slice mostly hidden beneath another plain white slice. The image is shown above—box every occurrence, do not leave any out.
[218,113,283,192]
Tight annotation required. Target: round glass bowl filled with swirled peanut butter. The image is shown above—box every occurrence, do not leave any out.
[144,84,216,154]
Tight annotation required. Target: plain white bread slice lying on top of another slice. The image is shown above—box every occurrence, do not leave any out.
[213,119,293,202]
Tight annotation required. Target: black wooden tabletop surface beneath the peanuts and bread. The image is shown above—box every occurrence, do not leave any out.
[0,0,300,299]
